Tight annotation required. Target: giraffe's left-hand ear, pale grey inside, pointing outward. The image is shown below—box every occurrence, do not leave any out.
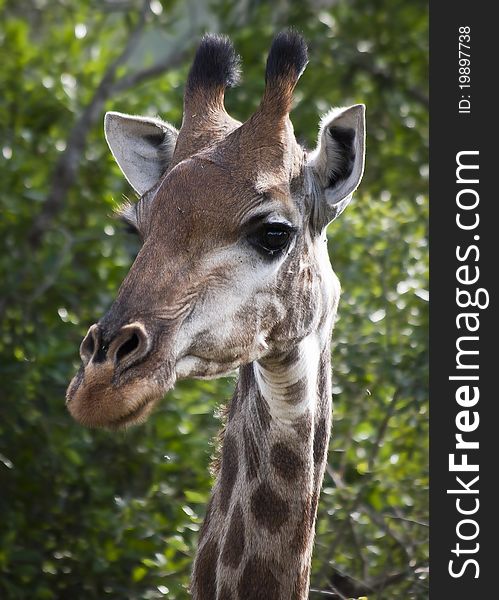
[104,112,178,195]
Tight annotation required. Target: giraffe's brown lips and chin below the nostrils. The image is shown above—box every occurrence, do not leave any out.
[66,364,174,430]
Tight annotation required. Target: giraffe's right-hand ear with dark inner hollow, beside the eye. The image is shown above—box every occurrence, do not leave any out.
[308,104,366,228]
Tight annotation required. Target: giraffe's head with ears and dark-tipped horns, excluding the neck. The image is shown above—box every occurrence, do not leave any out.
[67,32,365,428]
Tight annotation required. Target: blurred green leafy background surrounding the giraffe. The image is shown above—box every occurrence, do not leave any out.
[0,0,428,600]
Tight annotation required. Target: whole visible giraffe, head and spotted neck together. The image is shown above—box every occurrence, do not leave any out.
[66,31,365,600]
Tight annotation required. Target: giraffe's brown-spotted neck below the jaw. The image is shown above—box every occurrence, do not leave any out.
[192,333,331,600]
